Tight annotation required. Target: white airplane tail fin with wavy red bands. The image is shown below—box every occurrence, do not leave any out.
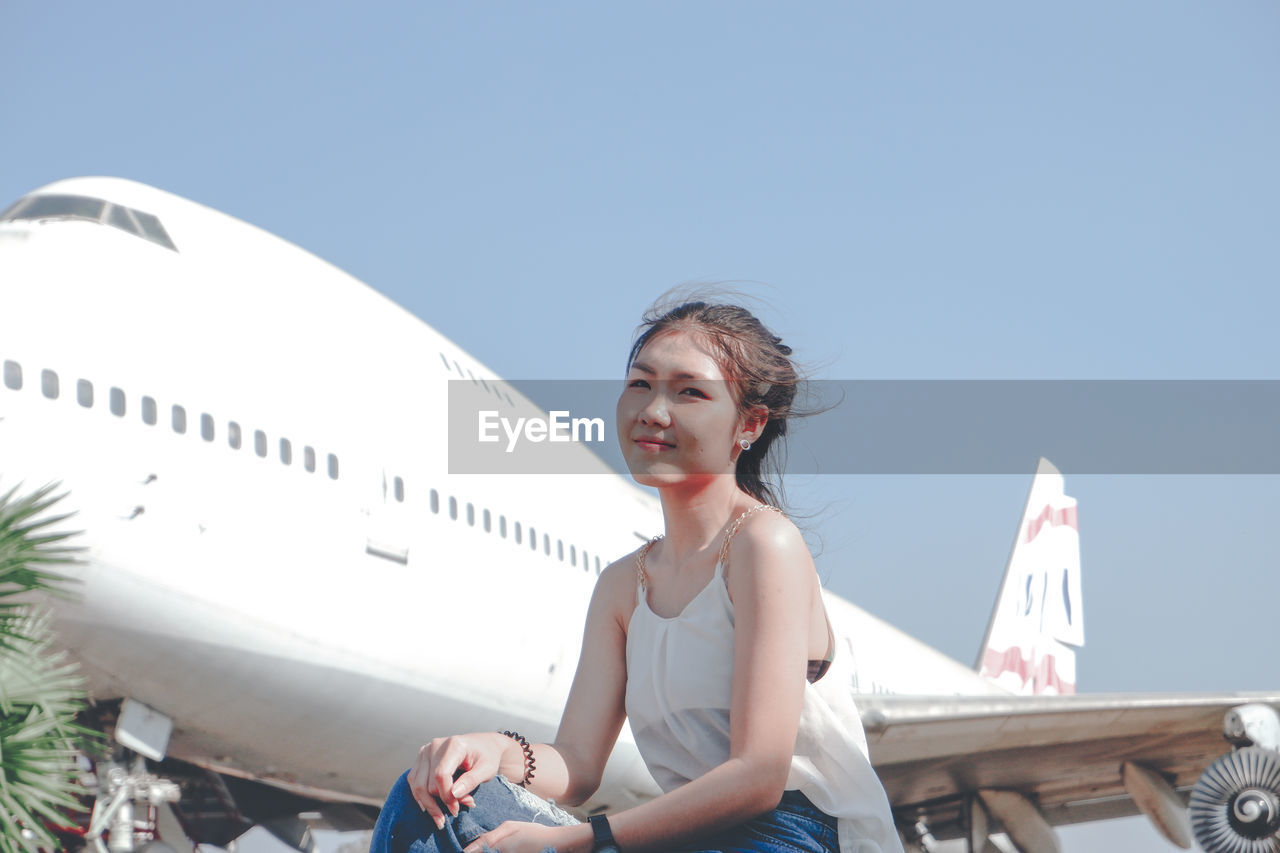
[974,457,1084,694]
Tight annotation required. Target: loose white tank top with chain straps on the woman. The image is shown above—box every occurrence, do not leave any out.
[626,514,902,853]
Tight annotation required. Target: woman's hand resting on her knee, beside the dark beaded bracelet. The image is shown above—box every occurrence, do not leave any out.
[408,731,514,829]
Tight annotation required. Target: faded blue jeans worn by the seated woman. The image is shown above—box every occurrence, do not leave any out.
[369,774,840,853]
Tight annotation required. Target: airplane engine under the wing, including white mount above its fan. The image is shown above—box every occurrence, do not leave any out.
[1189,704,1280,853]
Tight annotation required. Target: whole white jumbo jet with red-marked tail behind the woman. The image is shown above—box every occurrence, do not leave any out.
[0,178,1280,853]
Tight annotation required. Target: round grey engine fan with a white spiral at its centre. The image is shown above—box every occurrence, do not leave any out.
[1190,747,1280,853]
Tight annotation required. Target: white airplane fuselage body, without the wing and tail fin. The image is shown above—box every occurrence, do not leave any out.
[0,178,1001,807]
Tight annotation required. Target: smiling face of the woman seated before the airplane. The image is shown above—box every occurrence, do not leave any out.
[617,332,742,487]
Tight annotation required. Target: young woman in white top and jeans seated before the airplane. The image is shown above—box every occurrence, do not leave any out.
[371,302,902,853]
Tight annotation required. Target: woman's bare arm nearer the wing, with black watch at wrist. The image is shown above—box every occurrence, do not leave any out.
[468,516,817,853]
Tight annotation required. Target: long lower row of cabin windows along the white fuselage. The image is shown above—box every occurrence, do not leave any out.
[4,361,600,574]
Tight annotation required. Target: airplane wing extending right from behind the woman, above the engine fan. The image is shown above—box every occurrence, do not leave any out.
[855,693,1280,839]
